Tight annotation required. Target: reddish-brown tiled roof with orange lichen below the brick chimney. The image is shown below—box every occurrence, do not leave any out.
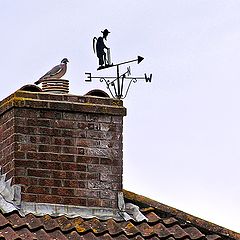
[0,190,240,240]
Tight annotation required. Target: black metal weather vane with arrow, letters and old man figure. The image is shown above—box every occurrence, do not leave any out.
[85,29,152,99]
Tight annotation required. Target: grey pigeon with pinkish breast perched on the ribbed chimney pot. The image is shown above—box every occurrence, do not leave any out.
[35,58,69,85]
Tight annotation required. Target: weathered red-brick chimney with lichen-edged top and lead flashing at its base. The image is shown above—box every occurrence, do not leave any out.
[0,91,126,217]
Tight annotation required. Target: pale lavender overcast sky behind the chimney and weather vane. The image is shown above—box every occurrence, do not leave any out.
[0,0,240,232]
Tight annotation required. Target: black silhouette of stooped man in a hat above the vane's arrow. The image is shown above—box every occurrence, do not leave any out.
[94,29,110,66]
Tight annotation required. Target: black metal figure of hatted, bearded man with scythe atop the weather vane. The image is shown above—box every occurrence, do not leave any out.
[93,29,111,69]
